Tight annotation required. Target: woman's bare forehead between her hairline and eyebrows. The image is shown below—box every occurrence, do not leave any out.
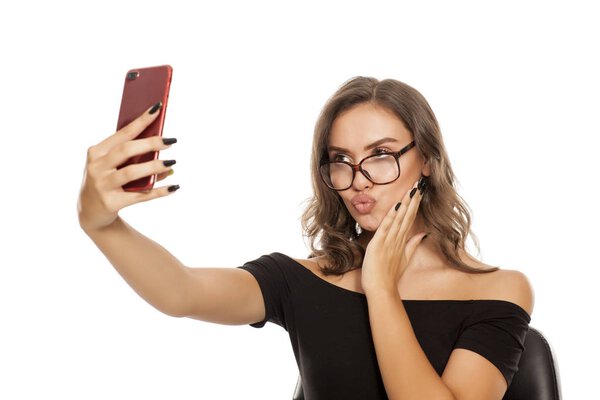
[328,103,412,152]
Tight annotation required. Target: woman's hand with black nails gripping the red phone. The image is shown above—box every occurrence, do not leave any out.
[77,103,179,232]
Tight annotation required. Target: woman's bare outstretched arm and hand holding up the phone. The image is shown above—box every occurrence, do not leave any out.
[78,104,265,325]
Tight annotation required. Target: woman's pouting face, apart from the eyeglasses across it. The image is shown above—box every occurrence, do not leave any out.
[327,103,429,232]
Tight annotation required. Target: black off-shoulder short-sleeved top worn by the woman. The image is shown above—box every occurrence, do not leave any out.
[239,253,530,400]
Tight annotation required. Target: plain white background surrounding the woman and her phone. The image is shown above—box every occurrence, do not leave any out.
[0,0,600,399]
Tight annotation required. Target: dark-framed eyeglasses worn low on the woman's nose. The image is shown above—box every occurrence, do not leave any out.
[319,141,415,191]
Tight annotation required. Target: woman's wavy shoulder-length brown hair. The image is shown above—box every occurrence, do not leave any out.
[302,77,497,275]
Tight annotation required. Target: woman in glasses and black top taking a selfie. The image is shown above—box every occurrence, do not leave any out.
[79,77,533,400]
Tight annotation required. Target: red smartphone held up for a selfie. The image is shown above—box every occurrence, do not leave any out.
[117,65,173,191]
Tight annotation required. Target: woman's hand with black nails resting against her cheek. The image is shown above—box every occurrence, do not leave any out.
[361,180,427,295]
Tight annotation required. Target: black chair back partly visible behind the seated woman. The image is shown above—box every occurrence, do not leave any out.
[292,327,561,400]
